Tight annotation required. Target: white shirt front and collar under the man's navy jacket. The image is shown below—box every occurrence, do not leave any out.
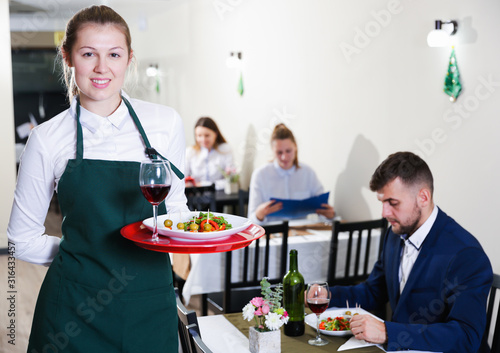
[399,205,438,293]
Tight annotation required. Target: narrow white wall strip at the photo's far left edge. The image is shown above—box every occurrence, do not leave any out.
[0,0,16,248]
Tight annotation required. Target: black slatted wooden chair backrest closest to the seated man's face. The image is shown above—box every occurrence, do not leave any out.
[328,218,387,285]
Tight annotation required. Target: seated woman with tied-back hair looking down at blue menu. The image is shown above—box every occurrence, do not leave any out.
[248,124,335,223]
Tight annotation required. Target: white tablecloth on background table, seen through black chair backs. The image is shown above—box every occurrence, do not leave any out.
[182,230,380,305]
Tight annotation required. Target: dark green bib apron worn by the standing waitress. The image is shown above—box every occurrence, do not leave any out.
[28,98,178,353]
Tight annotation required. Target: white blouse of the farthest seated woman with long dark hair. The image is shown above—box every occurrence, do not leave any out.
[186,143,234,189]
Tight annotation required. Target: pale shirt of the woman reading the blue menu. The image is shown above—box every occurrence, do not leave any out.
[248,161,323,224]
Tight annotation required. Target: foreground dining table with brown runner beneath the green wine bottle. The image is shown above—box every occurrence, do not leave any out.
[198,313,382,353]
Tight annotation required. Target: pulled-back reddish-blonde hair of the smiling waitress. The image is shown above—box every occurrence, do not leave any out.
[59,5,135,103]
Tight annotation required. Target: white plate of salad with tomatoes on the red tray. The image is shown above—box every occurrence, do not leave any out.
[142,211,251,242]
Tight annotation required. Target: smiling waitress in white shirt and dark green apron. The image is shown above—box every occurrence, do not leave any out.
[7,6,187,353]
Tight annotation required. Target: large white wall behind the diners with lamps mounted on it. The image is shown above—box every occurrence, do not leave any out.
[128,0,500,272]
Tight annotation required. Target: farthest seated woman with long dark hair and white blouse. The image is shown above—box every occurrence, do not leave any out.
[186,117,234,190]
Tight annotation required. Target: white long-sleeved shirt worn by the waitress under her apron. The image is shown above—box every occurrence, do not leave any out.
[7,92,188,266]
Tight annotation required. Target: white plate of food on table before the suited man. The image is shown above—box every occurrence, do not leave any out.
[305,308,366,336]
